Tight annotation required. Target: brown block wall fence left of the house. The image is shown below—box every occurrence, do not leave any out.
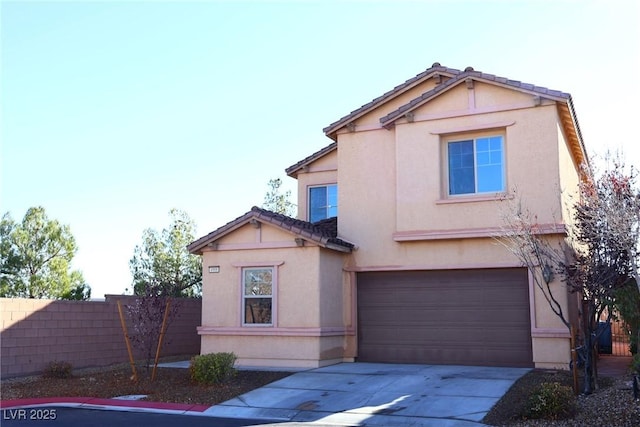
[0,295,202,378]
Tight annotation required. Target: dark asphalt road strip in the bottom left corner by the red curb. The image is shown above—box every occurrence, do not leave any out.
[0,407,278,427]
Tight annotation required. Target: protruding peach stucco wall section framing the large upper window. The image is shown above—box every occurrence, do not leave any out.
[392,102,560,231]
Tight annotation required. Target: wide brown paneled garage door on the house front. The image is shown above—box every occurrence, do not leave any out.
[358,268,533,367]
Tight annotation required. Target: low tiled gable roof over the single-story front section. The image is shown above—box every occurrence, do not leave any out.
[187,206,355,254]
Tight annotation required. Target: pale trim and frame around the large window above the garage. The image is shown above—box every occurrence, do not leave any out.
[441,129,508,202]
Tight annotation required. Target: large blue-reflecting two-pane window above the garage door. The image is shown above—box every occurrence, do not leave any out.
[447,135,505,196]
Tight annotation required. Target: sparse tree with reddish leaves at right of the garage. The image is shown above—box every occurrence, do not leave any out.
[497,155,640,394]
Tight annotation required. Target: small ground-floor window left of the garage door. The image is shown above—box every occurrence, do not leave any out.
[242,267,273,325]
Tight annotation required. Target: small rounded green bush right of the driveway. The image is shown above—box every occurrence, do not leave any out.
[526,382,576,419]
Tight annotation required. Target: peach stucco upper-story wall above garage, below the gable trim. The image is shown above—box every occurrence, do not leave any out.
[338,105,561,265]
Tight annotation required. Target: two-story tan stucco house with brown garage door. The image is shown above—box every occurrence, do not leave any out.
[189,63,587,368]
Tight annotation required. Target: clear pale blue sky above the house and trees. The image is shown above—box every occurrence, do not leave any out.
[0,0,640,297]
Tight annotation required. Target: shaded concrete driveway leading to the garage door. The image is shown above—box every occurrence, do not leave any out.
[202,363,529,427]
